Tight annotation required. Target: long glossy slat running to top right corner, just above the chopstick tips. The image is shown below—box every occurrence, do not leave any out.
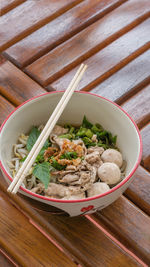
[26,0,150,85]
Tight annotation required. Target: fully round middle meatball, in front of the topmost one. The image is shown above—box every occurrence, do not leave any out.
[98,162,121,185]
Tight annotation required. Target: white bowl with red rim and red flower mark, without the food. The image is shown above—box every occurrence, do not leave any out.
[0,92,142,216]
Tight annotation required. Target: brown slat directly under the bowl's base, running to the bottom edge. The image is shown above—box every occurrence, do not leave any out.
[0,176,141,267]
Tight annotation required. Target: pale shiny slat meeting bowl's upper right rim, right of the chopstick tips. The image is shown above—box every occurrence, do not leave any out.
[91,51,150,107]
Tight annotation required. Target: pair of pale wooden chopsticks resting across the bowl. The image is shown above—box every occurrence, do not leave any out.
[7,64,87,194]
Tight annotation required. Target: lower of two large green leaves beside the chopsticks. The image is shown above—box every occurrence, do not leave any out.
[33,162,50,188]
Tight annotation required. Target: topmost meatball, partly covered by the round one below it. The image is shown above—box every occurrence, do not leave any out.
[101,148,123,168]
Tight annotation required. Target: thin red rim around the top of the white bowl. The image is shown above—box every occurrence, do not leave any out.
[0,91,142,203]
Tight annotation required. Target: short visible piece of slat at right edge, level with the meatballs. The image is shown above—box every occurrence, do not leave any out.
[141,123,150,172]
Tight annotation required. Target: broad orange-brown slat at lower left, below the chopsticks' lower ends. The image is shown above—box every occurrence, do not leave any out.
[0,192,76,267]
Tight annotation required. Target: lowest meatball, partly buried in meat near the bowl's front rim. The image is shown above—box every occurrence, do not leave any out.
[87,182,110,197]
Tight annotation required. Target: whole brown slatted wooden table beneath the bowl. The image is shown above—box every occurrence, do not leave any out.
[0,0,150,267]
